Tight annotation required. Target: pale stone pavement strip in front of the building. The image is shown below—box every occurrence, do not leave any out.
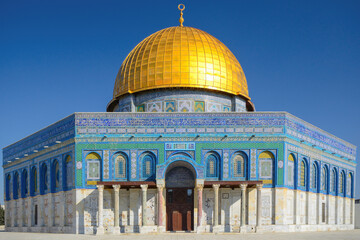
[0,229,360,240]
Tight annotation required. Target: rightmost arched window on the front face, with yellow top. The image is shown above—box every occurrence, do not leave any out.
[259,151,275,184]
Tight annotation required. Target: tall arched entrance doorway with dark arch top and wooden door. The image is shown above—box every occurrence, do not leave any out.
[165,162,195,231]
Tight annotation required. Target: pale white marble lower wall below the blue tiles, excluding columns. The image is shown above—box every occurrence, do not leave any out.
[5,188,355,234]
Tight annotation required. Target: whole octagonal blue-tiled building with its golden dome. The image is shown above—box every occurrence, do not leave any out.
[3,9,356,234]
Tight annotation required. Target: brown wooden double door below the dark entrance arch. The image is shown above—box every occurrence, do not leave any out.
[166,188,194,231]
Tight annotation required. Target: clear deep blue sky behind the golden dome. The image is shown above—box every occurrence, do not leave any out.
[0,0,360,202]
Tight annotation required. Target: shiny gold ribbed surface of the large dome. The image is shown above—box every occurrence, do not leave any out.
[113,27,250,99]
